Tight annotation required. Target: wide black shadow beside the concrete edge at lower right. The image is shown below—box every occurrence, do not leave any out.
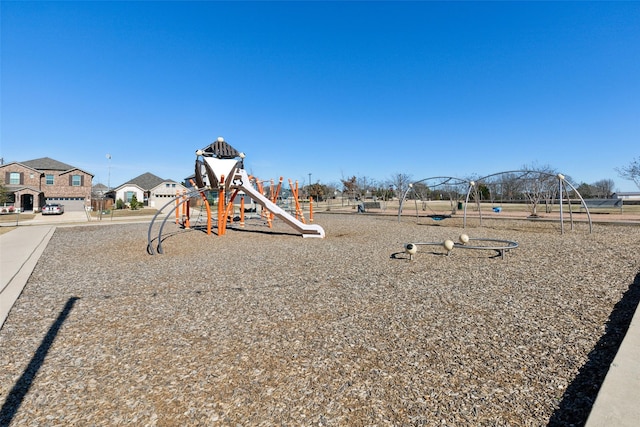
[547,274,640,427]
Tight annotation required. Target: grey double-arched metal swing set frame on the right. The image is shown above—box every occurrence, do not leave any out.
[398,170,593,234]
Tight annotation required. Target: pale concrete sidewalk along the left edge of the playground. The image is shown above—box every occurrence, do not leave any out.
[0,225,55,329]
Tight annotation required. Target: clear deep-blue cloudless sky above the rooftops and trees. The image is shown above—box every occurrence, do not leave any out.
[0,1,640,191]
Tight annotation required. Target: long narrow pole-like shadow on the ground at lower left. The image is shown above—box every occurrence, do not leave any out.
[0,297,80,426]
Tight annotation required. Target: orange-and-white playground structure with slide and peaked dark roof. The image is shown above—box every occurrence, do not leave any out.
[147,137,325,255]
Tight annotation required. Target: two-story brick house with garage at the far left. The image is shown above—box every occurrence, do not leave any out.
[0,157,93,212]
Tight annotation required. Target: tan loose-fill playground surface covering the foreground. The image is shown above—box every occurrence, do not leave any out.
[0,213,640,426]
